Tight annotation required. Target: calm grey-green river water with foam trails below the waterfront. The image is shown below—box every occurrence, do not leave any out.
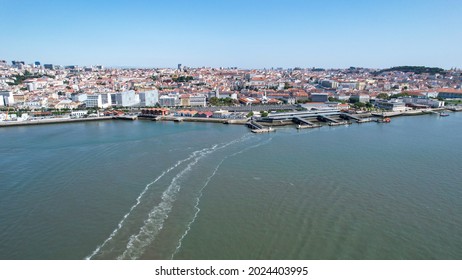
[0,113,462,259]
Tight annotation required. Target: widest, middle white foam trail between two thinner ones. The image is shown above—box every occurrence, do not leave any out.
[118,136,251,259]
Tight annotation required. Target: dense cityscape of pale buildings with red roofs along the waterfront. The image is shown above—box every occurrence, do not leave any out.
[0,60,462,122]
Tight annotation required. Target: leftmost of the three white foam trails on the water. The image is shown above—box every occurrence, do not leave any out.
[85,145,211,260]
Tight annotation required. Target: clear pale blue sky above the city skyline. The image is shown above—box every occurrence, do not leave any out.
[0,0,462,68]
